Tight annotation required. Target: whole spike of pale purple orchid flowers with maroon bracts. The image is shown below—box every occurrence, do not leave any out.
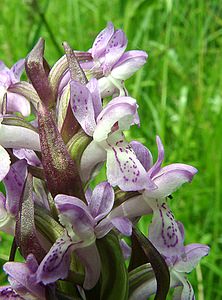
[0,22,209,300]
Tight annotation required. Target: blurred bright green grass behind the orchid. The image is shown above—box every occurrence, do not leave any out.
[0,0,222,300]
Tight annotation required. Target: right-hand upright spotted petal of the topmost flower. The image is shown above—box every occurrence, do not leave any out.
[103,29,127,76]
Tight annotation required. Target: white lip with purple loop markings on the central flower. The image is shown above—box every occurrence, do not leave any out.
[107,132,155,191]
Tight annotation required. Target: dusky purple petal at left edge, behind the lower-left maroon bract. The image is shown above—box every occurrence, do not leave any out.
[3,160,27,216]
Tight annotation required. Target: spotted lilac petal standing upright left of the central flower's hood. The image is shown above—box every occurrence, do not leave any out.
[70,80,96,136]
